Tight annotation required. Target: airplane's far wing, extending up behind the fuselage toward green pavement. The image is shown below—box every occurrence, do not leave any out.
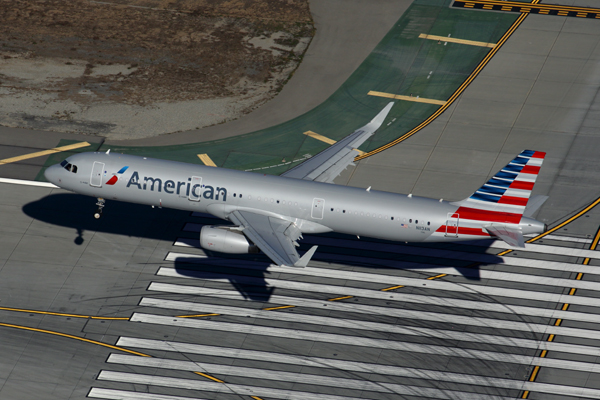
[281,102,394,183]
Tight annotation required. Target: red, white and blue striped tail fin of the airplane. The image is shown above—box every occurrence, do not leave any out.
[432,150,546,240]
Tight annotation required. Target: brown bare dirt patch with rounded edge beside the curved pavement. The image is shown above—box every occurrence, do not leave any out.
[0,0,314,138]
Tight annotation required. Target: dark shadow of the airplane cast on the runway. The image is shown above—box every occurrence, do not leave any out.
[23,193,502,301]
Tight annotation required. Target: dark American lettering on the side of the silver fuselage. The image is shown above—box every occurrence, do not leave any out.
[127,171,227,201]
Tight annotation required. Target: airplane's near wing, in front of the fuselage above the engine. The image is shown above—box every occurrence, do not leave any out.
[229,210,317,267]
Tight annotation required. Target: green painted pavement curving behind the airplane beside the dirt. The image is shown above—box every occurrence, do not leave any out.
[37,0,517,180]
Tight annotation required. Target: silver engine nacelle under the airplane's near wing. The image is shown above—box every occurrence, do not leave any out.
[200,225,258,254]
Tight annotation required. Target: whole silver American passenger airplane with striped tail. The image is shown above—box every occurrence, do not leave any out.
[45,102,547,267]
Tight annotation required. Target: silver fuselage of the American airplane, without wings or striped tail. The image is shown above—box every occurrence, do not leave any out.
[46,153,543,242]
